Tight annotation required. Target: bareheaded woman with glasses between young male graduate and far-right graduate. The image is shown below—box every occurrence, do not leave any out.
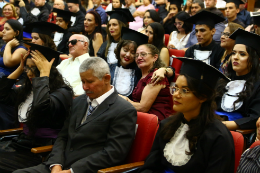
[219,22,244,74]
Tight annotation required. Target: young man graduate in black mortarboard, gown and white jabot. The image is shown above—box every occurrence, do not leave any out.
[185,10,225,69]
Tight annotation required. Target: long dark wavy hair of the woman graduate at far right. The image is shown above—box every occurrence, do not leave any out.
[216,46,260,109]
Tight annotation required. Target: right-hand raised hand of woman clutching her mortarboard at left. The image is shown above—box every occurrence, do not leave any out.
[31,50,55,77]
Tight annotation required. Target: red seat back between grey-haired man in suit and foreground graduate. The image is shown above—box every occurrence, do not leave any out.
[127,112,158,163]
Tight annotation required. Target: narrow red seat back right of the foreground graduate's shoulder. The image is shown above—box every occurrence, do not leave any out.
[230,131,244,173]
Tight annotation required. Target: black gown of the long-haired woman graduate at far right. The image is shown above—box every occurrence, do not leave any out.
[216,73,260,129]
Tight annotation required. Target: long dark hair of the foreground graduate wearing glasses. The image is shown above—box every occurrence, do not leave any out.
[160,73,220,155]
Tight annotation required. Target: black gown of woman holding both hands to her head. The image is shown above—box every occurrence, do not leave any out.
[0,77,73,173]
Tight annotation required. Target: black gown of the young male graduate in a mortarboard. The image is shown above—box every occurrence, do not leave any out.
[185,40,225,69]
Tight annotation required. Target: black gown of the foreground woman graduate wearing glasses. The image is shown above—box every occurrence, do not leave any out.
[139,117,235,173]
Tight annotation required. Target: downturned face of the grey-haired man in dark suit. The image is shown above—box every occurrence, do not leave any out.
[80,70,110,99]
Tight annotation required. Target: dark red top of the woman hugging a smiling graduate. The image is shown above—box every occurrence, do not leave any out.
[132,69,172,121]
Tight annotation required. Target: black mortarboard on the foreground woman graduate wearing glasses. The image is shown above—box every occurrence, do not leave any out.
[177,57,230,89]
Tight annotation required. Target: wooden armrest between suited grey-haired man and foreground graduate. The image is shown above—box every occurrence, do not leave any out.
[98,161,144,173]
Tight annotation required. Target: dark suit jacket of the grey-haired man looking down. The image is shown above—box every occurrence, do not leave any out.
[44,92,137,173]
